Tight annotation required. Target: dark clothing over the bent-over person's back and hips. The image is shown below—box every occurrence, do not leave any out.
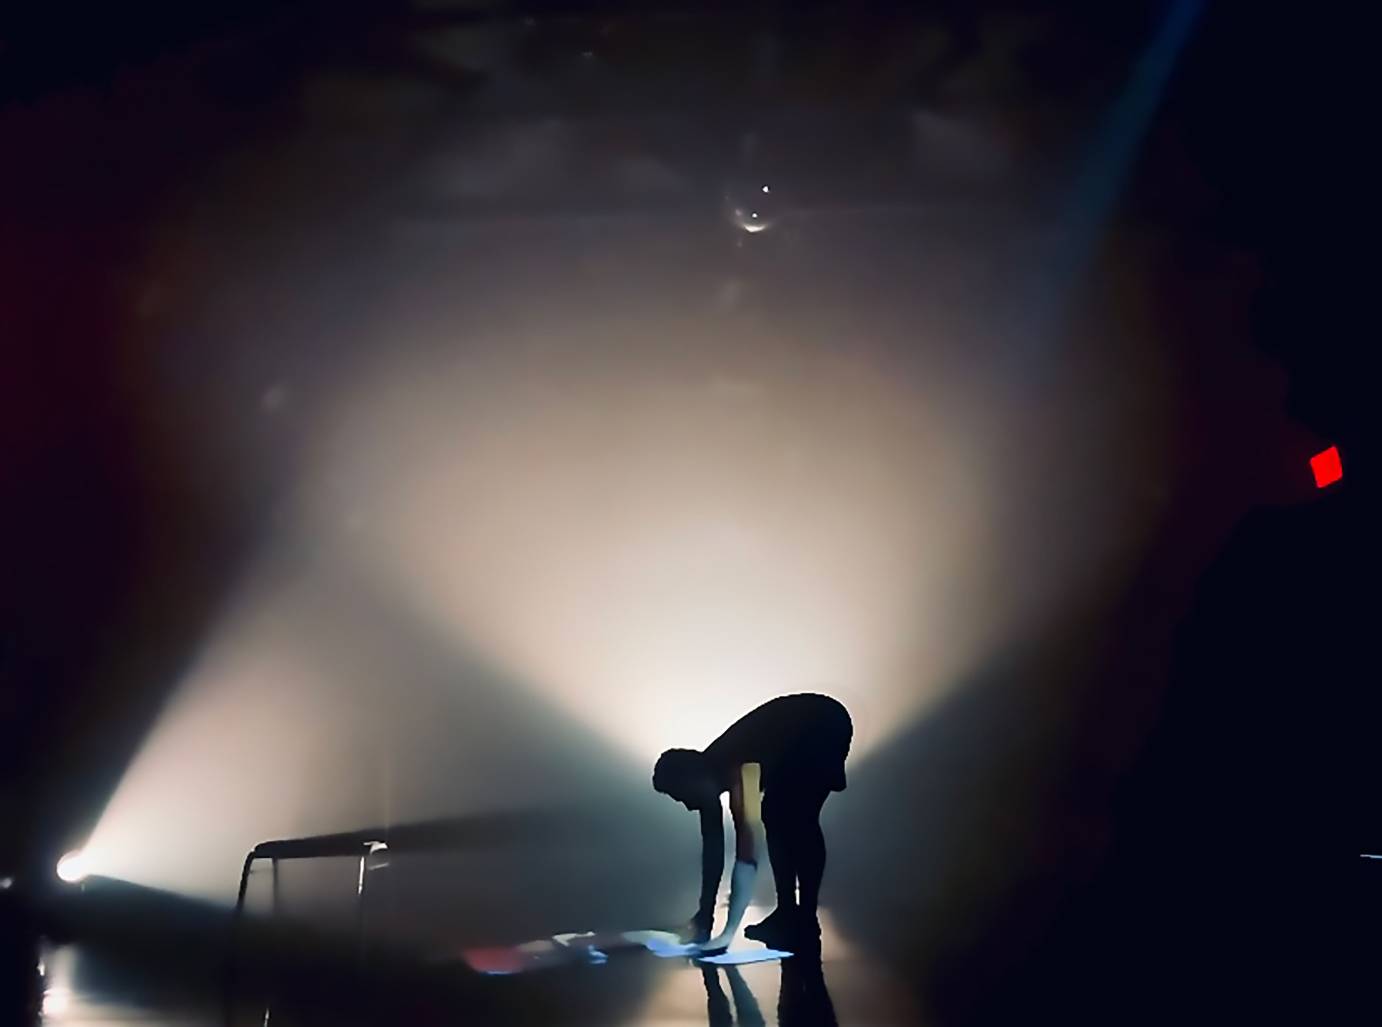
[705,692,854,792]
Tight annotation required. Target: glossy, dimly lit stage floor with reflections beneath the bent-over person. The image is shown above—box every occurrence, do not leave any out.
[44,910,922,1027]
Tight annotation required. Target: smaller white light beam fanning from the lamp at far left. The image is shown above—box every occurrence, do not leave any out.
[84,577,425,901]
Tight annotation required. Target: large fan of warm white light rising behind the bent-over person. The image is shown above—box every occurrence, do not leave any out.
[304,324,1013,767]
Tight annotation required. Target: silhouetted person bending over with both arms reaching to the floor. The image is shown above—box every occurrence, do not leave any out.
[652,694,854,950]
